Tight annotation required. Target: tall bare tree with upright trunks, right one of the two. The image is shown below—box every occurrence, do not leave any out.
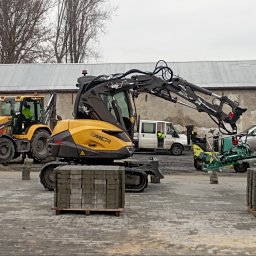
[54,0,114,63]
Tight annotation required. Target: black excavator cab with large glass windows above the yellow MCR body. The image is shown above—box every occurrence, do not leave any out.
[74,76,135,138]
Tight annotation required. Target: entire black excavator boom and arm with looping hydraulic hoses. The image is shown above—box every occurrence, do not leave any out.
[76,60,246,134]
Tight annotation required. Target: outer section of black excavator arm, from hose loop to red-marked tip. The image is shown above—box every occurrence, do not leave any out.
[131,74,246,134]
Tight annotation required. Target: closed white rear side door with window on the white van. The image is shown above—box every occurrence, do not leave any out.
[139,121,157,149]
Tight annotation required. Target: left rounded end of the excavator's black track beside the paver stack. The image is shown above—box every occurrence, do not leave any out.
[39,164,58,191]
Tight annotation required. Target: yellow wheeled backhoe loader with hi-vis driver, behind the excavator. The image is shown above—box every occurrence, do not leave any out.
[0,94,56,164]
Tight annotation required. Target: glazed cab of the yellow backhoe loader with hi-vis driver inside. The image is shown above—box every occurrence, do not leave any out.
[0,96,44,135]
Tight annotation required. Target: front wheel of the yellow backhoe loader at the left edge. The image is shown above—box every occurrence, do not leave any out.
[0,138,15,164]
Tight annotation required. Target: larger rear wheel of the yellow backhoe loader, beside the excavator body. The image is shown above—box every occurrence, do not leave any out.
[29,130,51,162]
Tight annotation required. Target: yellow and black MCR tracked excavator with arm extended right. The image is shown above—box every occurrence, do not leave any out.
[40,61,246,192]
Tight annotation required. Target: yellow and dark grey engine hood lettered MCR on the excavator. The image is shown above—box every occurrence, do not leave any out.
[49,119,133,160]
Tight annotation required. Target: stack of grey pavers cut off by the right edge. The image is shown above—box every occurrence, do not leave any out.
[246,168,256,214]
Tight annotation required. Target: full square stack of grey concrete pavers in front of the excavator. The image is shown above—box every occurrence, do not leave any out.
[54,165,125,210]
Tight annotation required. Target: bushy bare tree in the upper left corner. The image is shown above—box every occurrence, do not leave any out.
[0,0,52,63]
